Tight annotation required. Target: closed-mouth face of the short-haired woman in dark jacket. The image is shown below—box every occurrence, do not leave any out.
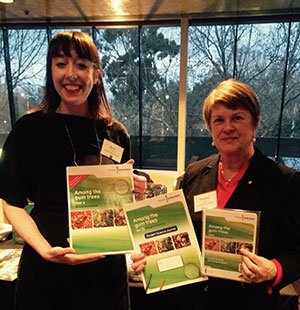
[210,103,256,156]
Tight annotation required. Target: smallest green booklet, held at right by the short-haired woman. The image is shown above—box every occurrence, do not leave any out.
[202,209,260,282]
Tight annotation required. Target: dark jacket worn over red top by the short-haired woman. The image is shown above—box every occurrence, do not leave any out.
[182,148,300,289]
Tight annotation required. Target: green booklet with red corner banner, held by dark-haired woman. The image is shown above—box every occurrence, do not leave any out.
[67,164,135,255]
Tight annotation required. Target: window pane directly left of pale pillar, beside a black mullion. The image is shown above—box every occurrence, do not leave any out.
[141,27,180,169]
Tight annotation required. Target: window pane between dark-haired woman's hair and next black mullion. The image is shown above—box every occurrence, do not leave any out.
[95,28,139,138]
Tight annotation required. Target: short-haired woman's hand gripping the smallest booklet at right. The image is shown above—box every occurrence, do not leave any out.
[241,249,277,283]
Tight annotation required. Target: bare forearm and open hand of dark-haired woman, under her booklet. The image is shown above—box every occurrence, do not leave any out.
[3,201,104,265]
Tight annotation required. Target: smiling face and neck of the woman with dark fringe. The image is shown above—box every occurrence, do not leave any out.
[51,50,99,116]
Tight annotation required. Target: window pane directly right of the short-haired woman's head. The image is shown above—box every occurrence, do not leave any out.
[236,23,288,157]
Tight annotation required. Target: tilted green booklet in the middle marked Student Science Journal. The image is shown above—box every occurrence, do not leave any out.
[124,190,207,293]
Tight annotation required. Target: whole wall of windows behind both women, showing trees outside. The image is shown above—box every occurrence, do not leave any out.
[0,21,300,170]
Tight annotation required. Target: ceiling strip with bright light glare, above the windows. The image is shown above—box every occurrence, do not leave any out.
[0,0,300,25]
